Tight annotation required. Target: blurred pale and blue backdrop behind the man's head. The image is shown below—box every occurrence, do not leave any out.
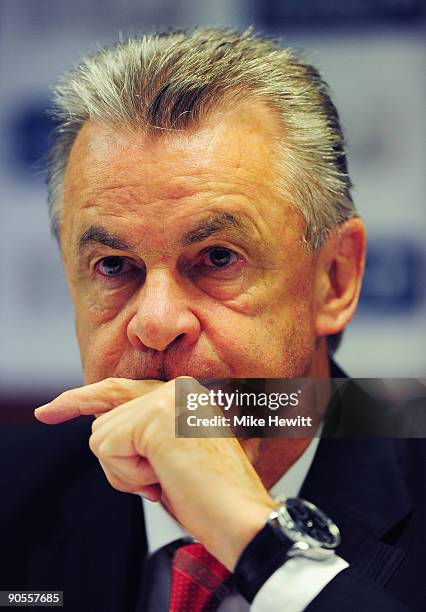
[0,0,426,420]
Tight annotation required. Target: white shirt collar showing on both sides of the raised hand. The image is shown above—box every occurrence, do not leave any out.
[143,437,320,552]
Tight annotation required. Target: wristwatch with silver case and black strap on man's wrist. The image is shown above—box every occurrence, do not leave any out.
[234,496,340,603]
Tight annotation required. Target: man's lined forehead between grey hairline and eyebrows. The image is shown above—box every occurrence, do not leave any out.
[62,103,296,251]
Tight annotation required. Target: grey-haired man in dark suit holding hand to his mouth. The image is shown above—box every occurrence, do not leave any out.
[1,30,424,611]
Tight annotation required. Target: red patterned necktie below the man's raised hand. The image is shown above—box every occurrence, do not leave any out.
[169,544,232,612]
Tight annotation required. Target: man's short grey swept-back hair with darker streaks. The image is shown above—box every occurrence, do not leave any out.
[47,29,357,352]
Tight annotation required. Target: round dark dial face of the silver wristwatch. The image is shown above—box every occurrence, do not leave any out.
[285,497,340,548]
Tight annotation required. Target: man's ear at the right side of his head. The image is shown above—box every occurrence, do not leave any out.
[315,219,367,337]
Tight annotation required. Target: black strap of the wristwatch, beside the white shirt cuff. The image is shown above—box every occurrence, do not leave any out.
[234,522,293,603]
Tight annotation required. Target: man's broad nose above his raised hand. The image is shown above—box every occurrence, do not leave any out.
[127,269,200,351]
